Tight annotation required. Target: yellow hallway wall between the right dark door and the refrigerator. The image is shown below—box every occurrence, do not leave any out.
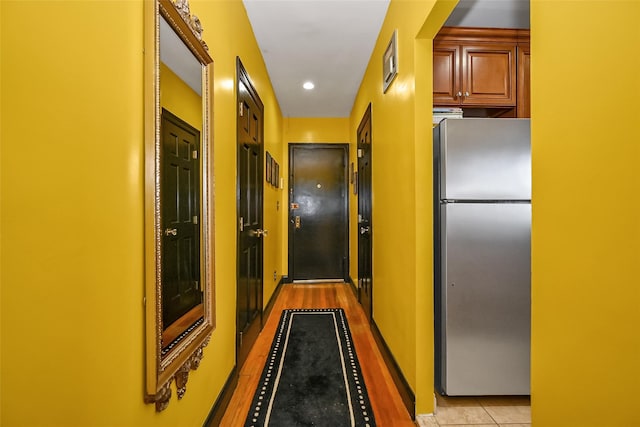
[350,0,456,413]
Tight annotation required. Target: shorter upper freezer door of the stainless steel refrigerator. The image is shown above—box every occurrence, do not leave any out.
[440,119,531,200]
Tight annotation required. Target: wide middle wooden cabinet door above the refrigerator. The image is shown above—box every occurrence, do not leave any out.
[462,44,516,106]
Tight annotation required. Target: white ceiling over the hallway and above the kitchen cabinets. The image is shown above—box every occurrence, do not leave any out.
[243,0,529,117]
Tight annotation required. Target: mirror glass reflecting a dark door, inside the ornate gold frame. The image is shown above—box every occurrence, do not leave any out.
[159,14,204,348]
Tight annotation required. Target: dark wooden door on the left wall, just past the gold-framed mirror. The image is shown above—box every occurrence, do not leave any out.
[236,60,264,367]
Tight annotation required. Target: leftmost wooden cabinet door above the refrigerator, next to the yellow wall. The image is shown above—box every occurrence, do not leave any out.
[433,43,460,105]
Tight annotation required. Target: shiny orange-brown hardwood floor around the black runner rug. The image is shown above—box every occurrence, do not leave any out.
[220,283,415,427]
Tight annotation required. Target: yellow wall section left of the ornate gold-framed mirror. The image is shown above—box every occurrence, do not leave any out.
[0,1,154,426]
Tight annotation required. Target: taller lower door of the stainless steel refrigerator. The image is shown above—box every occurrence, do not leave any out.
[440,203,531,396]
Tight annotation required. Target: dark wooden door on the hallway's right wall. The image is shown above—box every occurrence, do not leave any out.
[357,105,373,320]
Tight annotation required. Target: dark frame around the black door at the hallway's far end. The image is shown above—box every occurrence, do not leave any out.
[287,142,350,282]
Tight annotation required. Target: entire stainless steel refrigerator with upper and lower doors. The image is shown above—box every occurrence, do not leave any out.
[434,118,531,396]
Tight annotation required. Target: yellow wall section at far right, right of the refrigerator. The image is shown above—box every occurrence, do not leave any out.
[531,0,640,427]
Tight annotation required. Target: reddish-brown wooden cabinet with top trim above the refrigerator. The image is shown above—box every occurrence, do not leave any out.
[433,27,529,114]
